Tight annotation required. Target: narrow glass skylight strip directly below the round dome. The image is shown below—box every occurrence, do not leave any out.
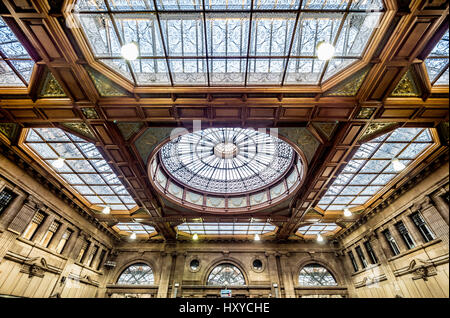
[177,222,276,236]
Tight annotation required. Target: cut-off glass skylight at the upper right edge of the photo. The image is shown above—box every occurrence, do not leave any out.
[425,30,449,85]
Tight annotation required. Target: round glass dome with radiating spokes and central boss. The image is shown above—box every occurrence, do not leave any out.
[160,128,295,193]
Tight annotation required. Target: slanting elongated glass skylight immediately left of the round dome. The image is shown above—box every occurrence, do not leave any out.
[24,128,136,210]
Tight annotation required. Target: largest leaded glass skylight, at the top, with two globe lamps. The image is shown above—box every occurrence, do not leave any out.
[75,0,383,86]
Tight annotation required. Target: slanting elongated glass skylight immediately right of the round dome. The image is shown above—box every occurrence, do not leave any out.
[318,128,434,210]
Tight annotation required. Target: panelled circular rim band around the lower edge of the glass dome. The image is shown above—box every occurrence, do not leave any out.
[147,129,308,215]
